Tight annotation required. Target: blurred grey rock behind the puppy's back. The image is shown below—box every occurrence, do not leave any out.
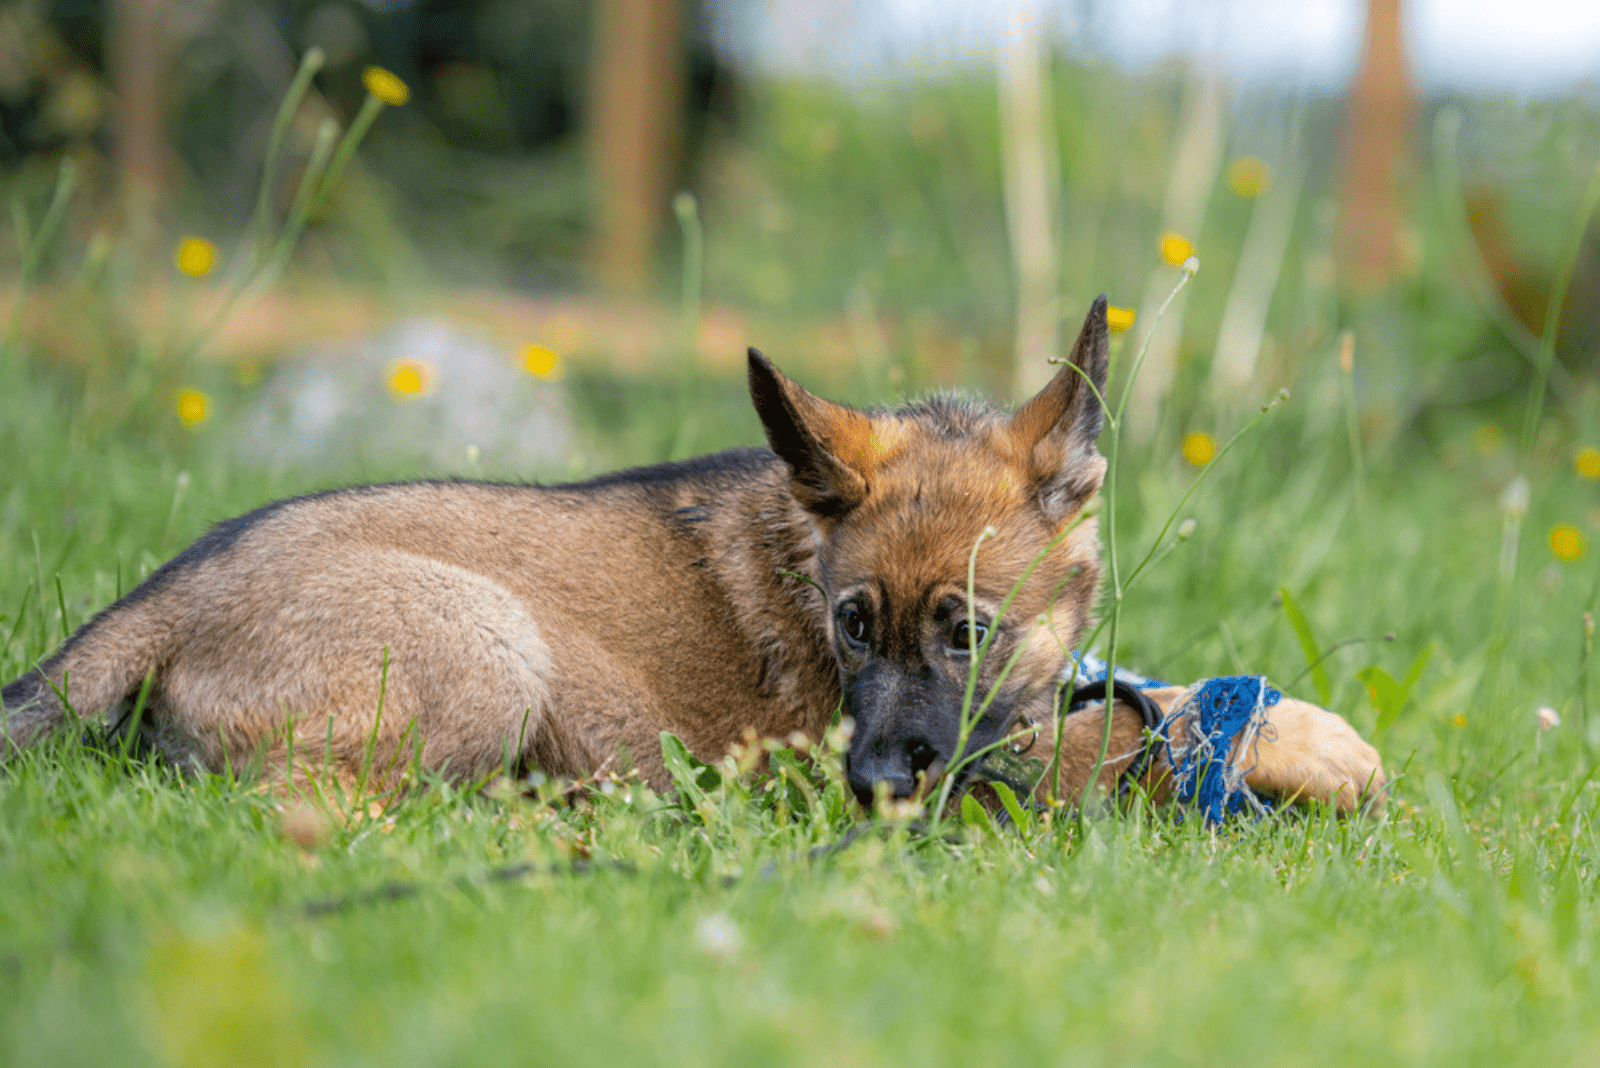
[232,318,571,476]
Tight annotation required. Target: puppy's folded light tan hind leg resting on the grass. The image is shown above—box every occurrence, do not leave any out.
[152,550,568,787]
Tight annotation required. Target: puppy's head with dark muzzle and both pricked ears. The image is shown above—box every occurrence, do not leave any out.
[750,297,1107,806]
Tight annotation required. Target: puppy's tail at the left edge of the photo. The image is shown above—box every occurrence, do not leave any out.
[0,590,170,766]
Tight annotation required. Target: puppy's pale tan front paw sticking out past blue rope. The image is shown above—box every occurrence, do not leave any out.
[1238,697,1387,815]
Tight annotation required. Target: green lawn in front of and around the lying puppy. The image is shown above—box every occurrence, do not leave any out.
[0,329,1600,1065]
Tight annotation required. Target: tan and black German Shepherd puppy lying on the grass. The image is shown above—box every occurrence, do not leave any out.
[0,297,1382,809]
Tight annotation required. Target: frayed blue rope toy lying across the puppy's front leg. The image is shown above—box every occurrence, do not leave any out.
[1067,654,1283,825]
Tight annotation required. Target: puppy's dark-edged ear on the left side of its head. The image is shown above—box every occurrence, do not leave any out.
[750,349,874,520]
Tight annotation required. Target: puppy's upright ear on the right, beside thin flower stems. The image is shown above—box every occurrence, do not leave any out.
[1010,293,1110,524]
